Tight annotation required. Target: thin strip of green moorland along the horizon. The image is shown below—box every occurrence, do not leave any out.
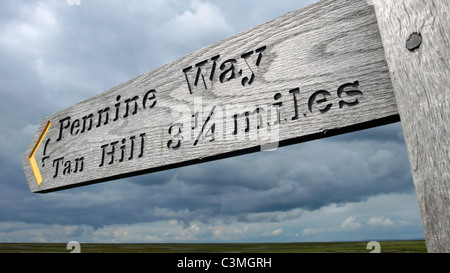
[0,240,427,253]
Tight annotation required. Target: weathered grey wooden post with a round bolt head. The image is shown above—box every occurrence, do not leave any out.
[373,0,450,252]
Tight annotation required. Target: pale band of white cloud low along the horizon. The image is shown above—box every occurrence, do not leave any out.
[0,191,423,243]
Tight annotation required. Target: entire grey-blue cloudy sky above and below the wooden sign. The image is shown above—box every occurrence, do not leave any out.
[0,0,423,242]
